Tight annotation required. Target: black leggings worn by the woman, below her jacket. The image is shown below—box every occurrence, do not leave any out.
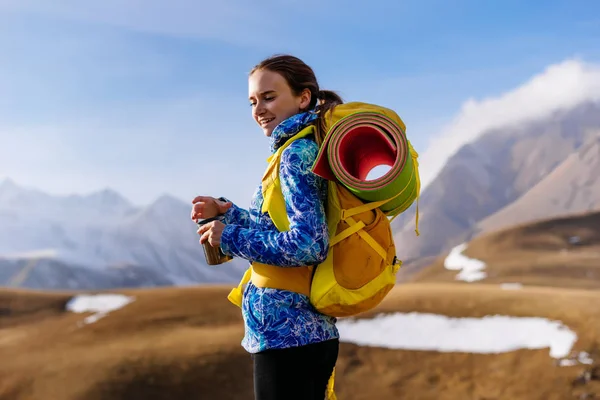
[252,339,339,400]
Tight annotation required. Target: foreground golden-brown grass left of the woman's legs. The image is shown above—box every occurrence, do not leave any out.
[0,288,252,400]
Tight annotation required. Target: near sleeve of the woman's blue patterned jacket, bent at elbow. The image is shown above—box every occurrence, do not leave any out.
[221,139,329,267]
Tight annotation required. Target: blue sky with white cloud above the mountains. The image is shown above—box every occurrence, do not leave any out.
[0,0,600,206]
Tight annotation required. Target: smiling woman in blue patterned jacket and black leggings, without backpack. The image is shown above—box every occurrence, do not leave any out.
[192,55,342,400]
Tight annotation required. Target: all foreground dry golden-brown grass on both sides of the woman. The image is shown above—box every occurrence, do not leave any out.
[0,283,600,400]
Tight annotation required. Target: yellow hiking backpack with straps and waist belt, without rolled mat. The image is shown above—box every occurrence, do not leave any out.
[228,103,420,317]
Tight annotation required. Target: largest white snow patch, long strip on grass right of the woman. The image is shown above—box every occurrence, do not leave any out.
[337,312,577,358]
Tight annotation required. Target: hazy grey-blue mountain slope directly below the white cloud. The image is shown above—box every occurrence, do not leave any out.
[393,103,600,261]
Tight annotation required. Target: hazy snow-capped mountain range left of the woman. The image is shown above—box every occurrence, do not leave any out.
[0,180,246,286]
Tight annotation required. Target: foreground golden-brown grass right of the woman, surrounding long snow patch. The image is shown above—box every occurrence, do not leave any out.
[339,283,600,399]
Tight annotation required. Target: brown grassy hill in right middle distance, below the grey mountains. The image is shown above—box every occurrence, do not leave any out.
[411,208,600,289]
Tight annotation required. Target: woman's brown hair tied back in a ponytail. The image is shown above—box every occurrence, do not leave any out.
[250,54,344,146]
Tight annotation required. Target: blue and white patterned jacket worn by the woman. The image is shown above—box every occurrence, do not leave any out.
[221,112,339,353]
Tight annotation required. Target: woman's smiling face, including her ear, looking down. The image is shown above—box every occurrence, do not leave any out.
[248,69,311,136]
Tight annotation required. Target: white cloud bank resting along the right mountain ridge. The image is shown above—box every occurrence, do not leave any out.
[420,60,600,186]
